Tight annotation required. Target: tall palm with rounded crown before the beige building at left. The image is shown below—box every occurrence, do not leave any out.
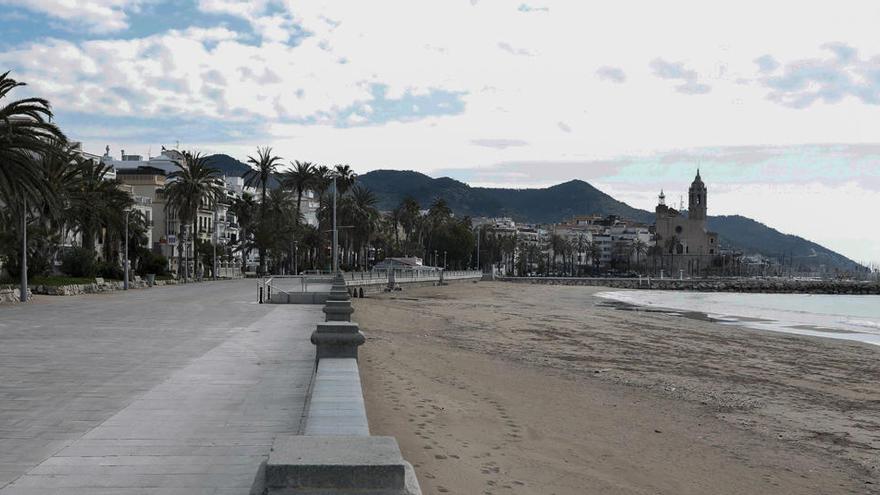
[163,151,224,277]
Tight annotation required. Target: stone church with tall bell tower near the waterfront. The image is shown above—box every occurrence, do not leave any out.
[654,169,719,275]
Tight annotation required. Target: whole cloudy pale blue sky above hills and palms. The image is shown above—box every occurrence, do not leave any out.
[0,0,880,263]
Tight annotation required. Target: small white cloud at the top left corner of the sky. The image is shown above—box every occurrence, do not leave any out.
[0,0,142,33]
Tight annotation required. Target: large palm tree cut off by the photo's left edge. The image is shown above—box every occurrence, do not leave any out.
[0,72,66,301]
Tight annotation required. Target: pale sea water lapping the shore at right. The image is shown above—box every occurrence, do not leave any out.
[598,290,880,345]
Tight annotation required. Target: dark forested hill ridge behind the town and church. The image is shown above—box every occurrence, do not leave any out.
[357,170,858,270]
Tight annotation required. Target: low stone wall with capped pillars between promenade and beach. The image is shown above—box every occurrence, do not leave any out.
[251,274,422,495]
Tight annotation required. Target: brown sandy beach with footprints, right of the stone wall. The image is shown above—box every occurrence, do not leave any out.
[354,282,880,495]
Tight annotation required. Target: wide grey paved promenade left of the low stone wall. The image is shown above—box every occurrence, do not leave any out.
[0,280,322,495]
